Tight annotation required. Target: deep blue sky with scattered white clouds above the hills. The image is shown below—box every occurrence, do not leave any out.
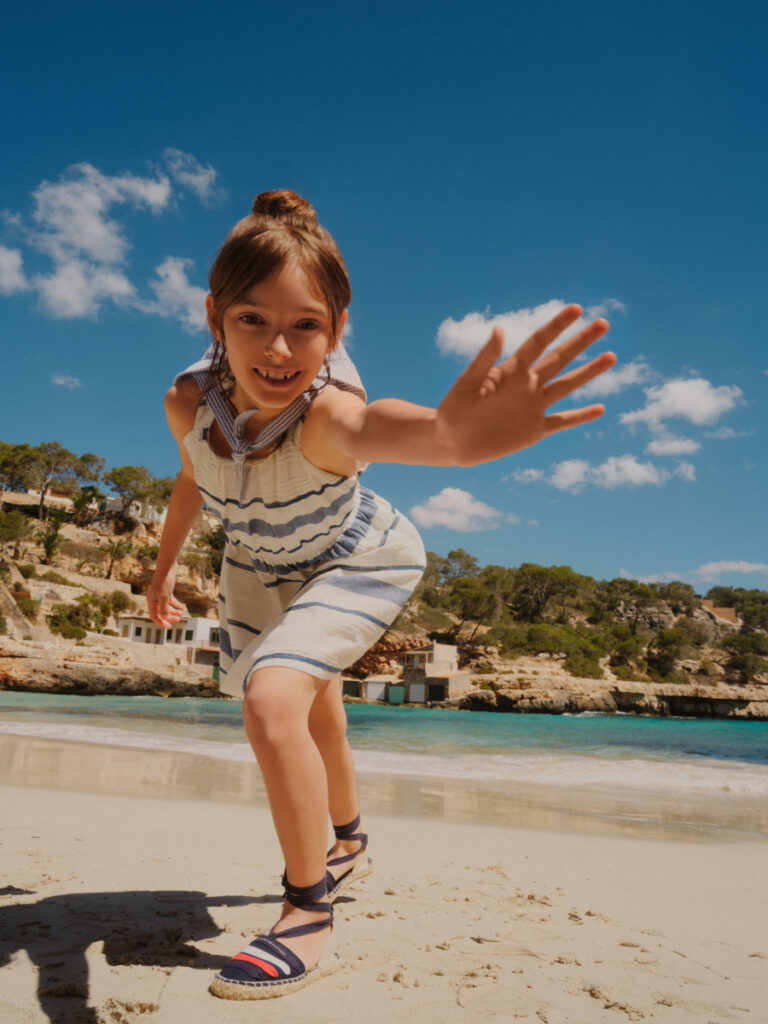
[0,0,768,593]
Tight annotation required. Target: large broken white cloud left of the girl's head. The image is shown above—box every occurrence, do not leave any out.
[0,150,216,331]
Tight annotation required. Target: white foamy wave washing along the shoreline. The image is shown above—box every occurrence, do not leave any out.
[0,722,768,797]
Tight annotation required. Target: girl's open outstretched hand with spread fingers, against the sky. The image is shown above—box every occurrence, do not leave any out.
[436,305,616,466]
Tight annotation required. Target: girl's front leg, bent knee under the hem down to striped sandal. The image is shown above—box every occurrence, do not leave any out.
[243,668,329,968]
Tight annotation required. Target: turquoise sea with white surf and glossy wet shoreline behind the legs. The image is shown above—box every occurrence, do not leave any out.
[0,691,768,838]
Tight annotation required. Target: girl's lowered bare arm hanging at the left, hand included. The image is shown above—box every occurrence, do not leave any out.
[146,382,203,628]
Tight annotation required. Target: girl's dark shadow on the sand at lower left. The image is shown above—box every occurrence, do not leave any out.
[0,886,272,1024]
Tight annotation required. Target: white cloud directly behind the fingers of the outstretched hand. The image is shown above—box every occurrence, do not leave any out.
[436,299,622,357]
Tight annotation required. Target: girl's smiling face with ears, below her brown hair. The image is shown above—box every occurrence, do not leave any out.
[208,264,346,422]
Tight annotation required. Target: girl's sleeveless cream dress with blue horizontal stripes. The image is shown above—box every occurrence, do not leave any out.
[184,382,425,697]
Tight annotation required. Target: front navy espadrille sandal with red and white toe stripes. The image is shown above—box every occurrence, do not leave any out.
[210,879,341,999]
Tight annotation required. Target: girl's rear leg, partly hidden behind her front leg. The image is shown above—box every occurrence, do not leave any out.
[309,676,368,878]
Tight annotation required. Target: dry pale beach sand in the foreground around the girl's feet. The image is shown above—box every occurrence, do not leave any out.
[0,744,768,1024]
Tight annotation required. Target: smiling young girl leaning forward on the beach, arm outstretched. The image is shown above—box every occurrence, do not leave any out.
[147,191,615,999]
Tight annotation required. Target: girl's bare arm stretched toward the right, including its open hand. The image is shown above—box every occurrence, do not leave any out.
[302,305,615,466]
